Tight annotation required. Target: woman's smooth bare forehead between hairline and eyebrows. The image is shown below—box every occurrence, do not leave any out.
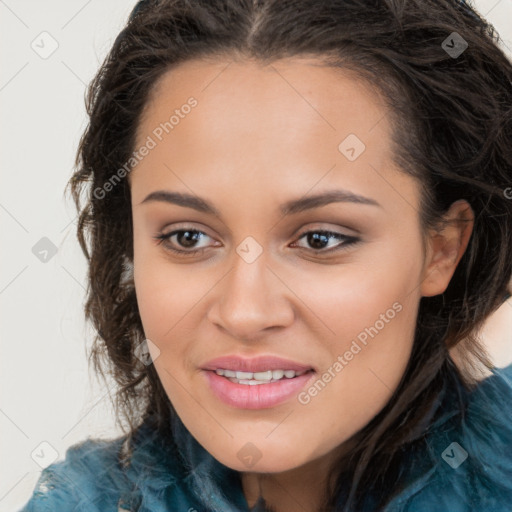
[130,58,416,217]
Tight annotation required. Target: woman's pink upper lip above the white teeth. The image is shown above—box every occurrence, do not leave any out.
[202,355,313,373]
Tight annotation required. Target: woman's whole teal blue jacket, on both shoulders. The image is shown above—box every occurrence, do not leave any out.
[20,365,512,512]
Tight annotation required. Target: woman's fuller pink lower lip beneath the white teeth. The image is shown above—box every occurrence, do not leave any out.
[204,371,314,409]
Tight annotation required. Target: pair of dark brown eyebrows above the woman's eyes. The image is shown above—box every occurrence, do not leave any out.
[140,190,382,217]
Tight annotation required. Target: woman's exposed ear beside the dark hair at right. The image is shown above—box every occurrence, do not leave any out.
[421,199,475,297]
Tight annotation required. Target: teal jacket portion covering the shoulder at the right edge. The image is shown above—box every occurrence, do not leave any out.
[386,365,512,512]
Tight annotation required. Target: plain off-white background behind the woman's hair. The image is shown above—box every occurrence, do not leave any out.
[0,0,512,511]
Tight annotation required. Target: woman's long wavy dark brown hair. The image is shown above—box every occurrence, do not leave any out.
[68,0,512,510]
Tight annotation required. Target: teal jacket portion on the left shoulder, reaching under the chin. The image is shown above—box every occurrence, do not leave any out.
[19,412,244,512]
